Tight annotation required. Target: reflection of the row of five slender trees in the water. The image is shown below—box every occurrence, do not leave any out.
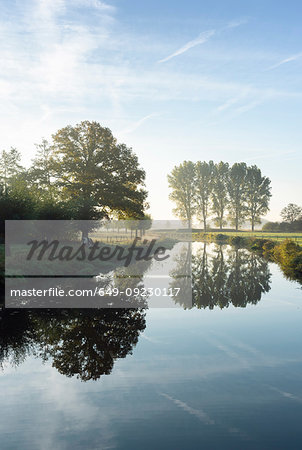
[171,243,271,309]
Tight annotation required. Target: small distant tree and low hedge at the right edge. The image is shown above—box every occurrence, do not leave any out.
[262,203,302,232]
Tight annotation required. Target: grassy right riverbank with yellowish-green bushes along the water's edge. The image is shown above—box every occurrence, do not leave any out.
[192,233,302,283]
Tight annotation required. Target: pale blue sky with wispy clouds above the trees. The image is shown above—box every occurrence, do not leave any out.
[0,0,302,220]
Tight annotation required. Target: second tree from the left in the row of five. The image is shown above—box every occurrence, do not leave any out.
[195,161,214,231]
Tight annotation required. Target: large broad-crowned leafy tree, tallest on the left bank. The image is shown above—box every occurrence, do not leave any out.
[52,121,147,230]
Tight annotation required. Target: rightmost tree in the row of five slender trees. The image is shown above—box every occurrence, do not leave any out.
[245,166,271,231]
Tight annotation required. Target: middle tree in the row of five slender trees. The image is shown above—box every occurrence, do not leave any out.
[212,161,229,230]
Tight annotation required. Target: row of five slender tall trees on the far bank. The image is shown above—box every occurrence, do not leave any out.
[168,161,271,231]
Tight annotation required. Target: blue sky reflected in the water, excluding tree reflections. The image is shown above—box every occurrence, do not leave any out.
[0,250,302,450]
